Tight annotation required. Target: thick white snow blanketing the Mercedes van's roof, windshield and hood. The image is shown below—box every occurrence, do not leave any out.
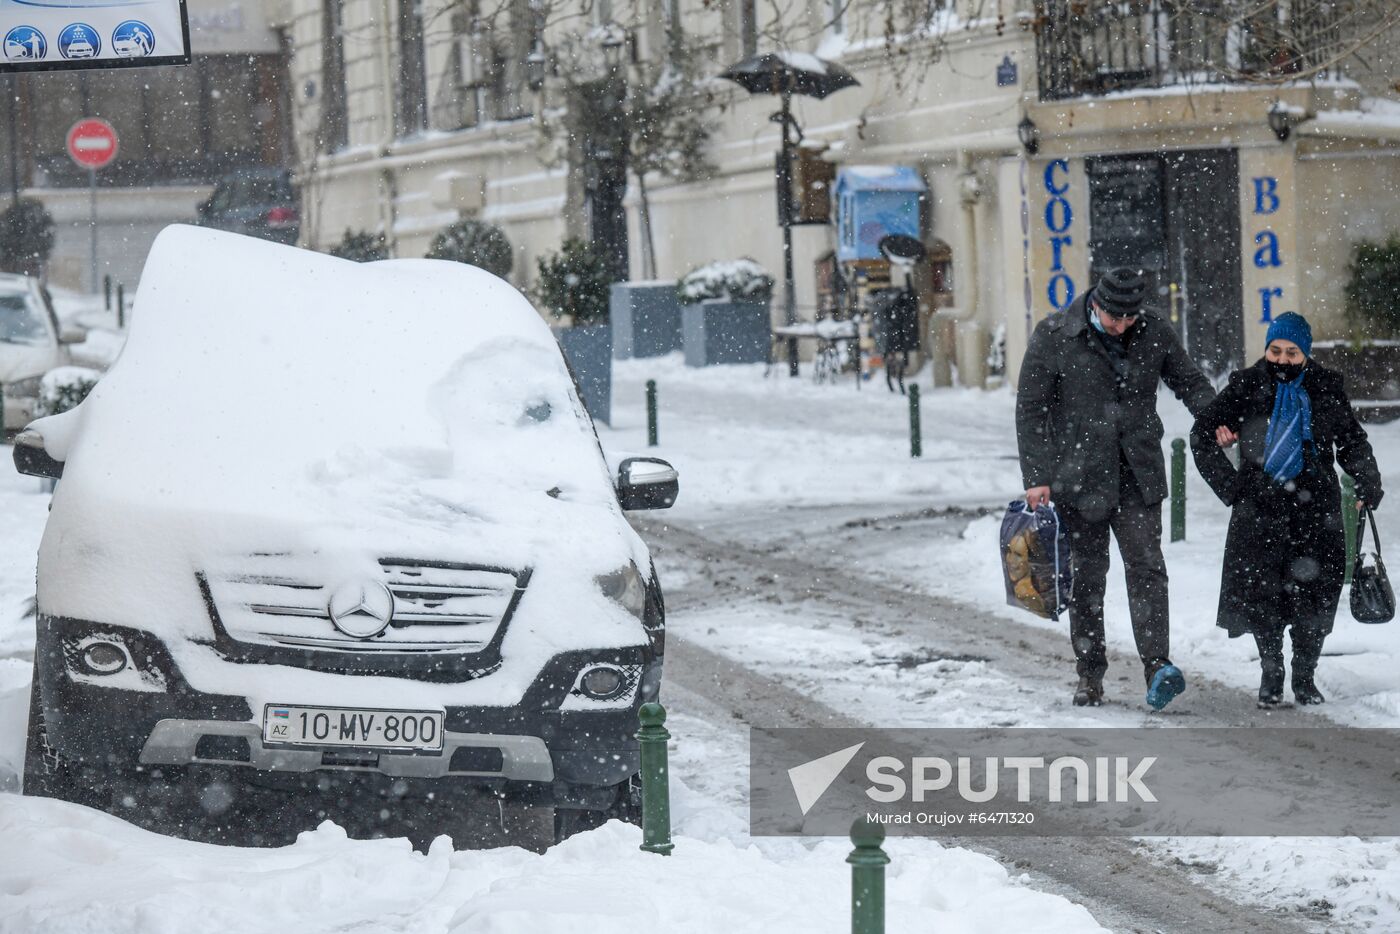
[36,227,645,708]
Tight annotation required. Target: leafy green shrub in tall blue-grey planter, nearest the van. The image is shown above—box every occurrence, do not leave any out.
[535,238,612,424]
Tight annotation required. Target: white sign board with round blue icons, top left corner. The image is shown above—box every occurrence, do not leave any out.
[0,0,189,71]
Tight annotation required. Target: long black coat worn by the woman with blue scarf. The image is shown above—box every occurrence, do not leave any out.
[1191,360,1382,636]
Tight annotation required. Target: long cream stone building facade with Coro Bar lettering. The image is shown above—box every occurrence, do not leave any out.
[286,0,1400,385]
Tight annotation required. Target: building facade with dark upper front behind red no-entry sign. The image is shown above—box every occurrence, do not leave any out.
[0,0,291,290]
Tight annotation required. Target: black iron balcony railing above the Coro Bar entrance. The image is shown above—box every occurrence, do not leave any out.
[1036,0,1348,101]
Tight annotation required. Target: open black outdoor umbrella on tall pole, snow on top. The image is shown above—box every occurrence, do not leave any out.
[720,52,860,377]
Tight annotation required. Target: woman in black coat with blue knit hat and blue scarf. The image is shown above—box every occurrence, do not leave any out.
[1191,312,1382,709]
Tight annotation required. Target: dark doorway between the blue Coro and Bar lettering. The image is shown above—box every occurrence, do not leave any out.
[1086,150,1245,377]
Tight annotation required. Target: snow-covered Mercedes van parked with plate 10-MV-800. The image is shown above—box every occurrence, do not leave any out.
[14,227,678,846]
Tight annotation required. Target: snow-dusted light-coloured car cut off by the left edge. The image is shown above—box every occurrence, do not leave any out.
[0,273,87,431]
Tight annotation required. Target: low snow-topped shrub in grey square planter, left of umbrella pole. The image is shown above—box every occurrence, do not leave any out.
[676,259,773,367]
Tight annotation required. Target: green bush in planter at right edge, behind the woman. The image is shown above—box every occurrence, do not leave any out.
[1312,234,1400,421]
